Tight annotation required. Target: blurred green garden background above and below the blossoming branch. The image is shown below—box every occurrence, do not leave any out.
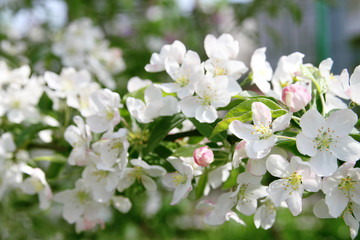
[0,0,360,239]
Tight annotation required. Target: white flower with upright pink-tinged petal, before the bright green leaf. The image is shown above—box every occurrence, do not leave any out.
[229,102,291,158]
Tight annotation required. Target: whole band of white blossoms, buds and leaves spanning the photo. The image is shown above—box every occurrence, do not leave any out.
[0,30,360,238]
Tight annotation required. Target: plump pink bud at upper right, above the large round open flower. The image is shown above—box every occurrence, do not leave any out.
[282,84,311,112]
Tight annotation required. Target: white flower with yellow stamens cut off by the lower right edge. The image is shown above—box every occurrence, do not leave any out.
[322,162,360,217]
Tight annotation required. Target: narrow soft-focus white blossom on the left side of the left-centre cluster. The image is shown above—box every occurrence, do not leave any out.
[64,116,92,166]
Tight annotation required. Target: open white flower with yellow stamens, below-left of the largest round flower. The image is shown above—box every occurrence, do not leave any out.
[266,154,320,216]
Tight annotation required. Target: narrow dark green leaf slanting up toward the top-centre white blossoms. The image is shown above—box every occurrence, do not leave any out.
[144,114,185,155]
